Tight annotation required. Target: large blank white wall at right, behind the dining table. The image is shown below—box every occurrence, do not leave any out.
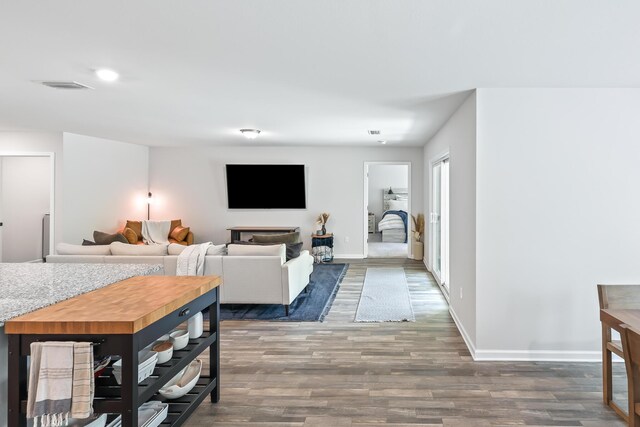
[476,89,640,360]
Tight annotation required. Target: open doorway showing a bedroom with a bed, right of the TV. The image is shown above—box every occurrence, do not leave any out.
[364,162,411,258]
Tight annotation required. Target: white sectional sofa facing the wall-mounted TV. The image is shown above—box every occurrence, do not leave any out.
[47,242,313,314]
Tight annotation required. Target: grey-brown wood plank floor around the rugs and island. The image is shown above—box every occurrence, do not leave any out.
[187,259,625,427]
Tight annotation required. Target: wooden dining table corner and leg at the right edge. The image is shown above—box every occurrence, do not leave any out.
[600,308,640,421]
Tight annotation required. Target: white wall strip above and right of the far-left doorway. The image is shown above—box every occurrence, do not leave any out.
[0,132,63,249]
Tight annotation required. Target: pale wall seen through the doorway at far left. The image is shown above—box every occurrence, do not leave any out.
[0,156,51,262]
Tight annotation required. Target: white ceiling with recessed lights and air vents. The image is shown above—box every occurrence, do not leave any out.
[0,0,640,146]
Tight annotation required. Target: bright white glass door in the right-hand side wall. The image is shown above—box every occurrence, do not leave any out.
[429,154,449,293]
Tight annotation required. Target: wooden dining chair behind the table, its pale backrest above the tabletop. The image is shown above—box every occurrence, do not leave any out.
[598,285,640,412]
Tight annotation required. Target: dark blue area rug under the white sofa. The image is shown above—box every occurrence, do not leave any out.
[220,264,349,322]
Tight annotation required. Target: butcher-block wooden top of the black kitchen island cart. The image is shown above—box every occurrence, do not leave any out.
[5,276,222,334]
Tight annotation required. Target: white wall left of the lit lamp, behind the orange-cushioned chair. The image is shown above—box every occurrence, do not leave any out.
[63,133,149,244]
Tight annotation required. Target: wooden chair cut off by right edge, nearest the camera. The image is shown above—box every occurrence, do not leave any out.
[620,325,640,427]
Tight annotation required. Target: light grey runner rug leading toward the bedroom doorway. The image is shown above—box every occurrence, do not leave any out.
[355,267,416,322]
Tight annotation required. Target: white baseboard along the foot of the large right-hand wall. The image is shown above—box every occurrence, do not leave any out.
[474,350,602,363]
